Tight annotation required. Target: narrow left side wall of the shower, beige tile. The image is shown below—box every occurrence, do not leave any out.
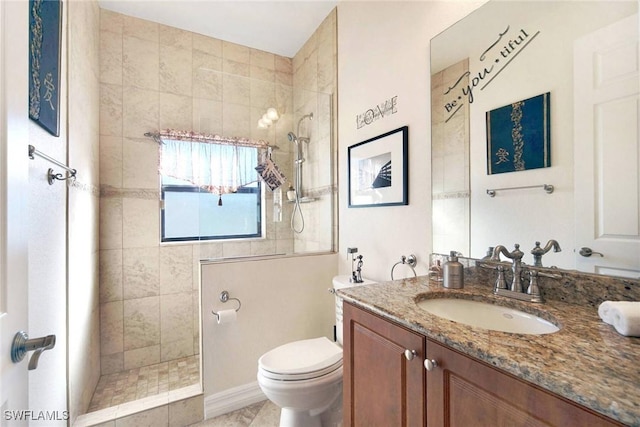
[67,1,100,418]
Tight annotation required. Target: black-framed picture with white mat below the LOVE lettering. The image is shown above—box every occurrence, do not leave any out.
[347,126,409,208]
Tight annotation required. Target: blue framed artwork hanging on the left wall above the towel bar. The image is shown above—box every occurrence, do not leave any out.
[29,0,62,136]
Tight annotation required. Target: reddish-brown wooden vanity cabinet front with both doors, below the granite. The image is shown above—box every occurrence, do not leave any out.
[343,302,623,427]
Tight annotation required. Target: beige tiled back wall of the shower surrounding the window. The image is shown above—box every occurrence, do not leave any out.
[100,9,300,374]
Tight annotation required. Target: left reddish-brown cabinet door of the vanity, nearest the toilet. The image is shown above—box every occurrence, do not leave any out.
[343,302,426,427]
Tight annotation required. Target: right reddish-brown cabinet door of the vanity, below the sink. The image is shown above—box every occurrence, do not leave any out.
[427,340,621,427]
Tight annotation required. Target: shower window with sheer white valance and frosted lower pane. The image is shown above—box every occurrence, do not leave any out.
[160,139,263,242]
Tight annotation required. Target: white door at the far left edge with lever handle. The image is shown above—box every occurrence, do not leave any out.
[0,0,29,426]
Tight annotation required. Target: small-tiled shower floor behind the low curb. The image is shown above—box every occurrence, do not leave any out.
[87,355,200,412]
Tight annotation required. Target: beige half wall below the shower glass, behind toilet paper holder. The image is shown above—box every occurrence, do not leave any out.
[202,254,336,398]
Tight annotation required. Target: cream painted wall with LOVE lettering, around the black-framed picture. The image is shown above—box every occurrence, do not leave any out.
[338,1,482,280]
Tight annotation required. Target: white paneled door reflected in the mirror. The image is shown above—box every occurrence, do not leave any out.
[574,14,640,277]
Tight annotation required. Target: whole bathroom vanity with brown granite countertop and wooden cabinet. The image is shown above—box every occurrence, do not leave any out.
[339,269,640,426]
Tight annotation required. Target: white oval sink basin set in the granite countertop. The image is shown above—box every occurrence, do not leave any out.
[417,298,560,335]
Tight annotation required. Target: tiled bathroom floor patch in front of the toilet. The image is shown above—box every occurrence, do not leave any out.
[191,400,280,427]
